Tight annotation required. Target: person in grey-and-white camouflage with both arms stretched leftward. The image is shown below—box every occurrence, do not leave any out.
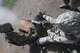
[37,11,80,44]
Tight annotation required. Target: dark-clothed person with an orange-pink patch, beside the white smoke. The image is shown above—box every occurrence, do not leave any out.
[0,21,38,46]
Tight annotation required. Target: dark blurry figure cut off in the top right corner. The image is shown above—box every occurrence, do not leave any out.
[60,0,80,11]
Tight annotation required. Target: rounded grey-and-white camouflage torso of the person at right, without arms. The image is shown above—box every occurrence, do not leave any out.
[56,11,80,38]
